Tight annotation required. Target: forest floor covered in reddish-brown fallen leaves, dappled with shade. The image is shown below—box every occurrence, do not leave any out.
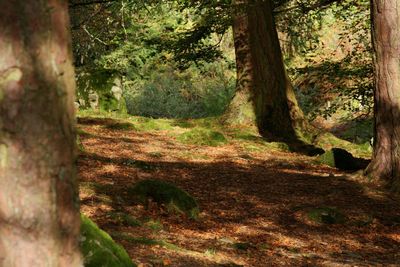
[78,117,400,267]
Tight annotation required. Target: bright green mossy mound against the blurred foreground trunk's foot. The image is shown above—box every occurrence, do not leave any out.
[81,215,135,267]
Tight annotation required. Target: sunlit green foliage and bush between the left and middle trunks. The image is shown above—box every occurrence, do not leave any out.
[73,2,235,118]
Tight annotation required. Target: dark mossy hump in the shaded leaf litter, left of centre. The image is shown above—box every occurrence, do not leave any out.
[128,180,199,219]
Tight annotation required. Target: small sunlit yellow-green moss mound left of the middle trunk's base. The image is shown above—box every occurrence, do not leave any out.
[177,128,228,146]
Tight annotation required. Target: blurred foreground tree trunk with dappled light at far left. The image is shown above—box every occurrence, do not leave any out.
[0,0,82,267]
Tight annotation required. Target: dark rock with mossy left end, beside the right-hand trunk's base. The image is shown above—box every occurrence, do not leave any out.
[318,148,369,171]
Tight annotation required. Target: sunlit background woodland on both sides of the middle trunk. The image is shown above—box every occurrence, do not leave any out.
[71,1,373,149]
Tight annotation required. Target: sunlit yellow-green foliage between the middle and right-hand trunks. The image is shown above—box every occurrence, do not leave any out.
[282,0,373,120]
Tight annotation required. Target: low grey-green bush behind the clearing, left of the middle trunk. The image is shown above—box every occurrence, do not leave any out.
[124,63,235,118]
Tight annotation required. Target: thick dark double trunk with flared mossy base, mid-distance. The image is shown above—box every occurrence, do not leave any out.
[224,0,310,141]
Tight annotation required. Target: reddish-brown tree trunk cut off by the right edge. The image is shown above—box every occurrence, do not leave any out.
[366,0,400,193]
